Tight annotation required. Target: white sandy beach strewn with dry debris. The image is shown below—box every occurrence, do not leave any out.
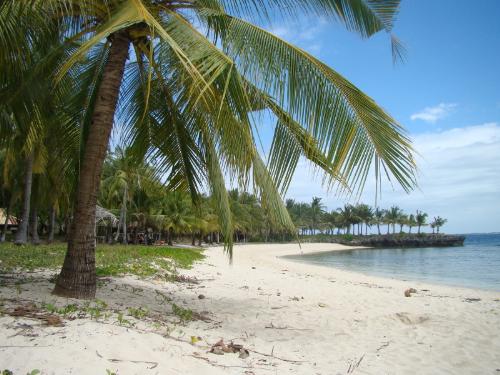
[0,244,500,375]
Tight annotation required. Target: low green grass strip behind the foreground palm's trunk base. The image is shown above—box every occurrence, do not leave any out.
[0,243,204,277]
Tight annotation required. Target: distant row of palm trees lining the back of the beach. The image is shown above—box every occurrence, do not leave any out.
[0,147,446,245]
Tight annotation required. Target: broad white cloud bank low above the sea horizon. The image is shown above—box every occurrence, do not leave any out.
[288,123,500,233]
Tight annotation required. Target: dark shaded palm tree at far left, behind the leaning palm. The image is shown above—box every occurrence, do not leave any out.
[0,16,79,244]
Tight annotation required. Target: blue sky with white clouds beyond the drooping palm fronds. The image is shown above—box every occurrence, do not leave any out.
[263,0,500,233]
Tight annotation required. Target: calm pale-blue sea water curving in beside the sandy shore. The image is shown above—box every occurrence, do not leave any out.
[286,234,500,291]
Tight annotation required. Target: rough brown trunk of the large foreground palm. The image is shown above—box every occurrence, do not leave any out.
[53,31,130,298]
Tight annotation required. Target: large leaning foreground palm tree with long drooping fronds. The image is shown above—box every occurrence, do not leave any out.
[0,0,415,298]
